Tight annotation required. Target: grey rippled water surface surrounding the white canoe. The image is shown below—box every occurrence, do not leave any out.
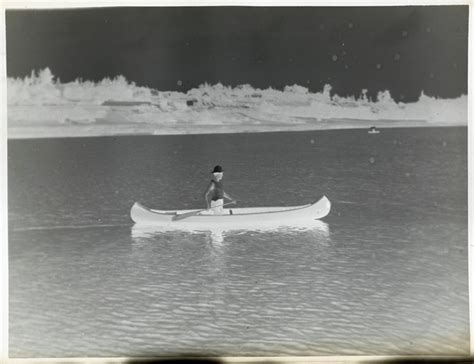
[8,128,469,357]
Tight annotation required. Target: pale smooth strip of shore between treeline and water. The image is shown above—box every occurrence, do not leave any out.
[7,119,467,140]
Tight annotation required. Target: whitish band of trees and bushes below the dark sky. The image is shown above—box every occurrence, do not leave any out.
[7,68,467,125]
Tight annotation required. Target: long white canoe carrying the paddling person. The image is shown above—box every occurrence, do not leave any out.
[130,196,331,227]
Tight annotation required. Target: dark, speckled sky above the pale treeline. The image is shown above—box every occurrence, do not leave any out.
[6,6,468,101]
